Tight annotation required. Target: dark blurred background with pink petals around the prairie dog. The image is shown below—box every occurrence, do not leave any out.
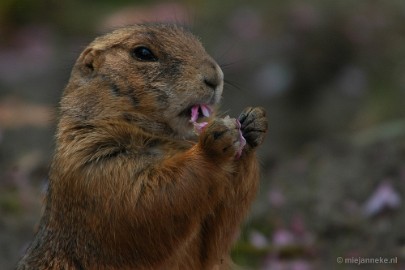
[0,0,405,270]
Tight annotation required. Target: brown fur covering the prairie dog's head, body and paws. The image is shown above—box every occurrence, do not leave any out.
[18,24,267,270]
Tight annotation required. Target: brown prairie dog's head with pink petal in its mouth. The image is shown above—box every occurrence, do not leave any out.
[61,24,223,138]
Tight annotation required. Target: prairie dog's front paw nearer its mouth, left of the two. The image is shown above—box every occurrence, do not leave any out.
[200,116,246,158]
